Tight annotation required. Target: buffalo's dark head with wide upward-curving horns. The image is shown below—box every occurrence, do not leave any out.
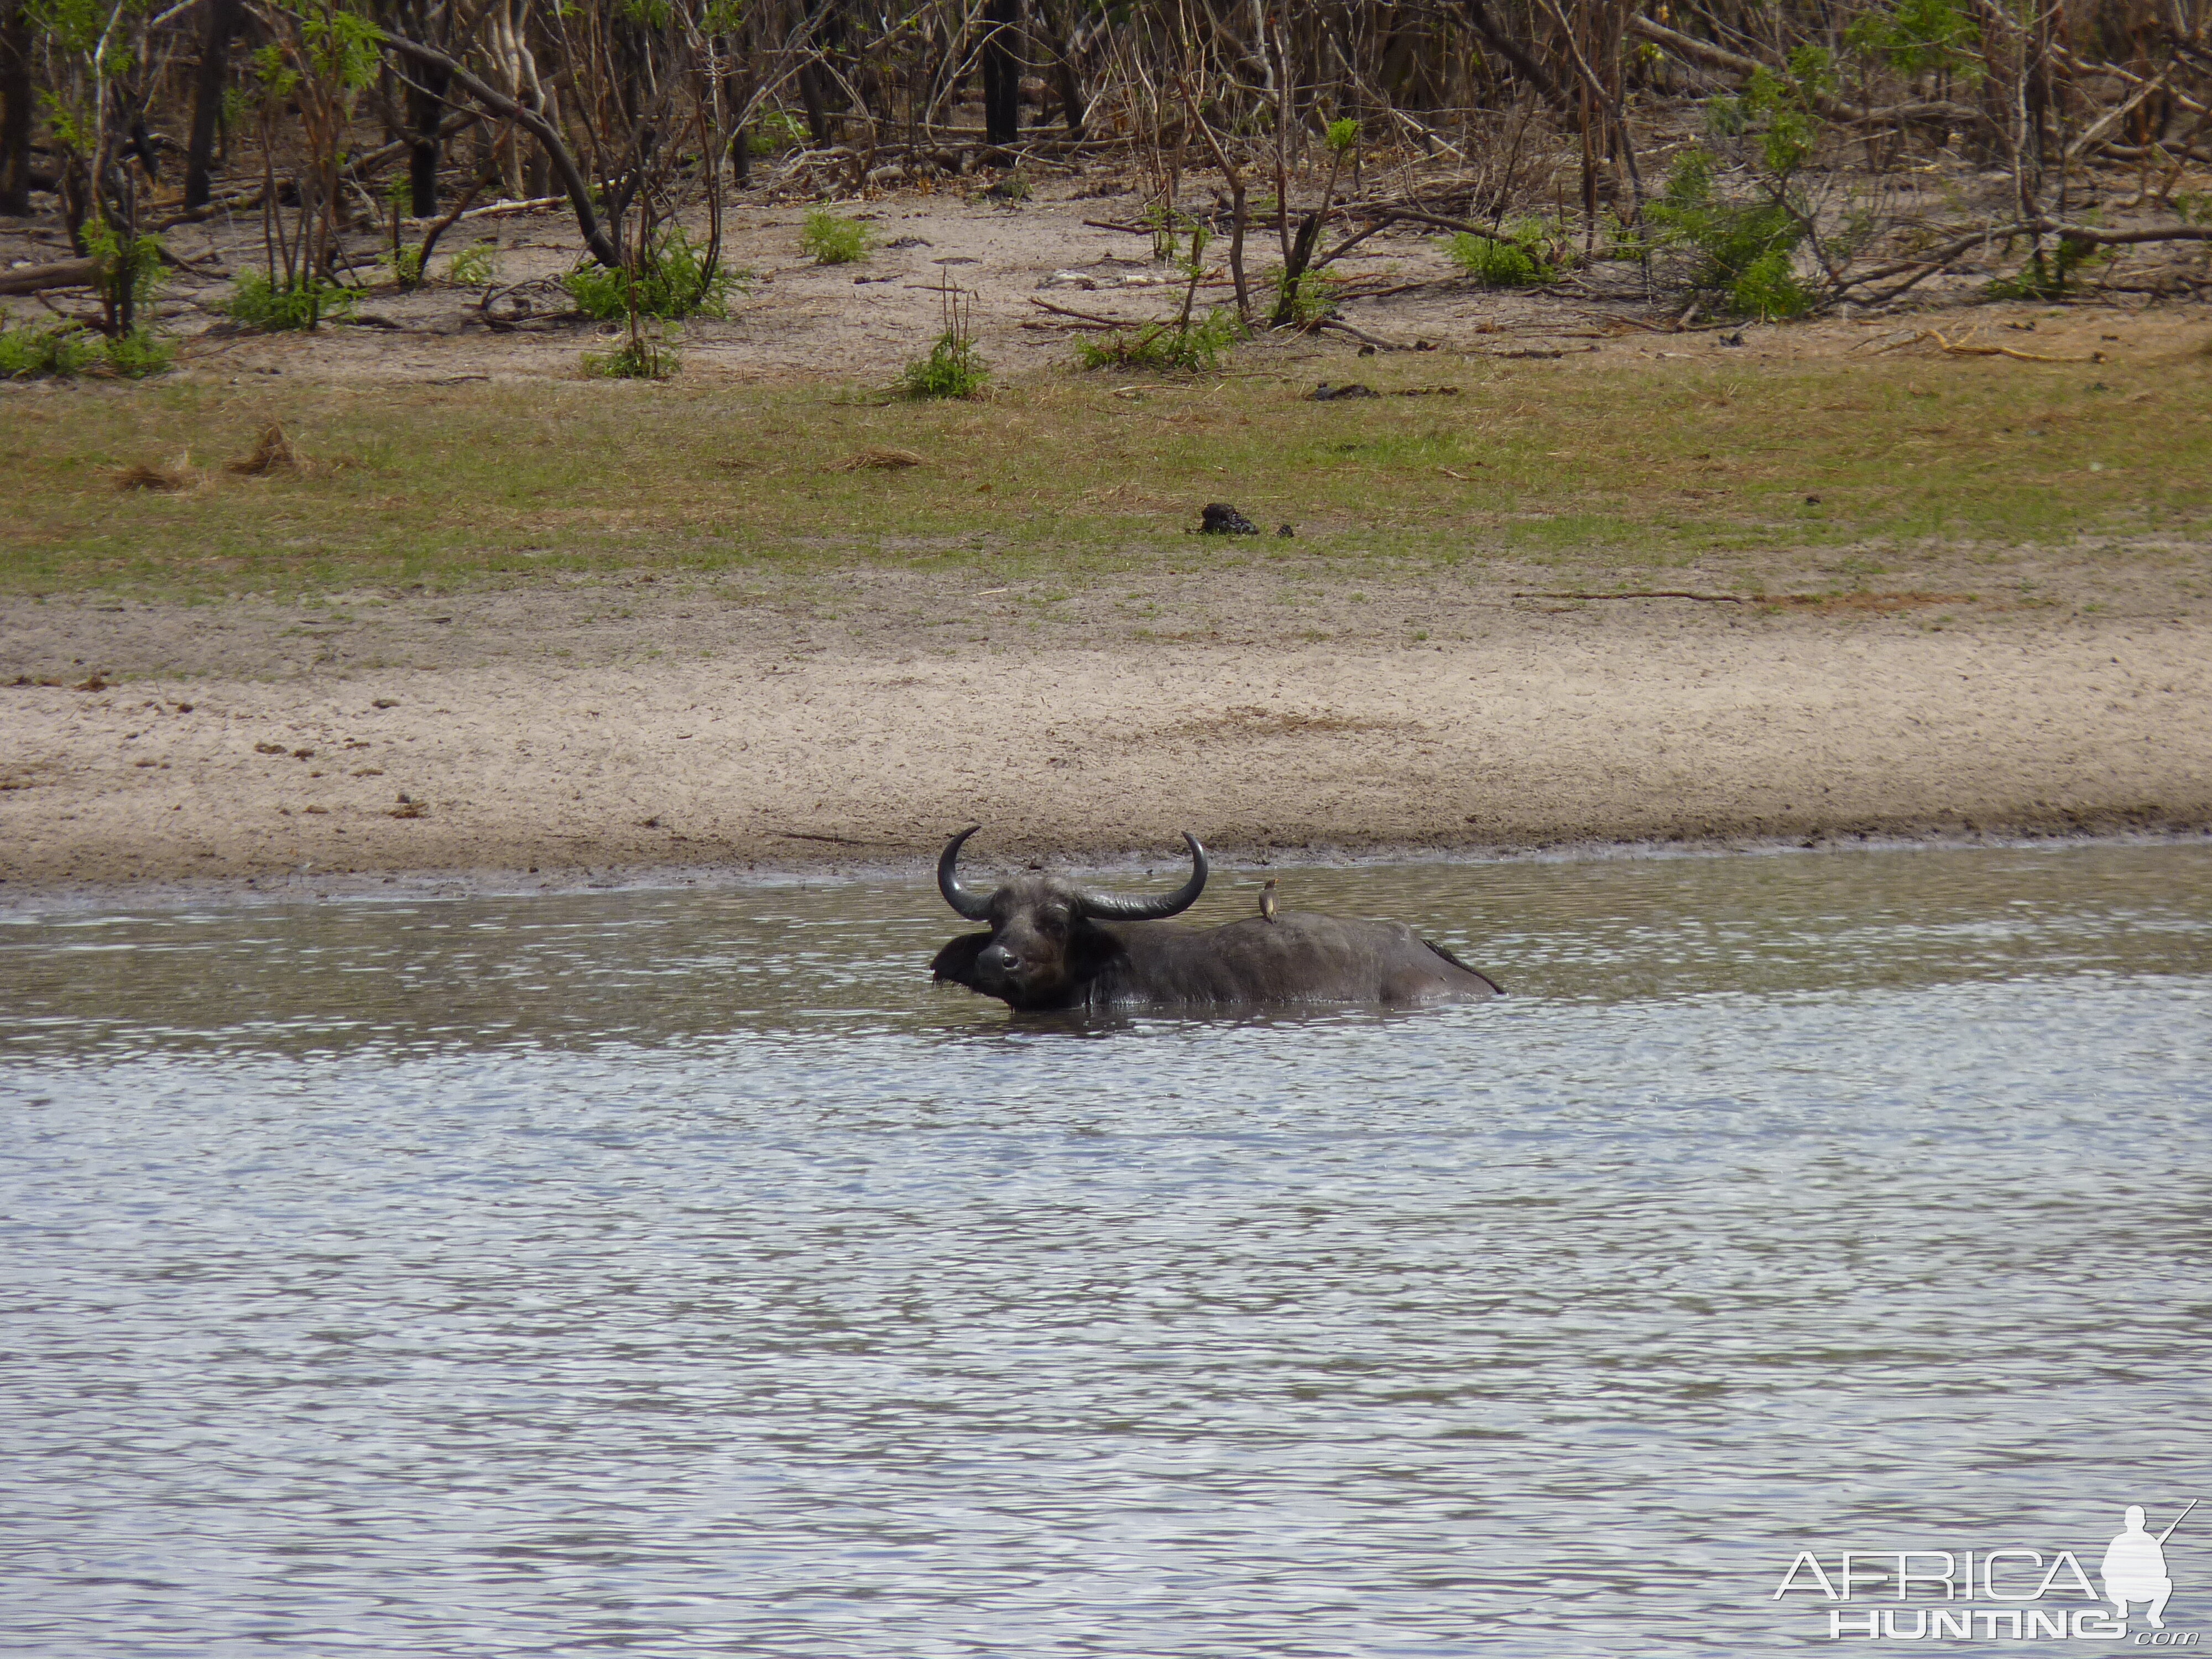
[933,825,1206,1009]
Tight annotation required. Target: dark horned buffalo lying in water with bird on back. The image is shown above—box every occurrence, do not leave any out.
[931,825,1498,1013]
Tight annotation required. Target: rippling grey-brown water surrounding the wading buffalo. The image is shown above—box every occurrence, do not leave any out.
[0,847,2212,1659]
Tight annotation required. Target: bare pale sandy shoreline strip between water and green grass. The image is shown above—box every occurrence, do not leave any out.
[0,588,2212,898]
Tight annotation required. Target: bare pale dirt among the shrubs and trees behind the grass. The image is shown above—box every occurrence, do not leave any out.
[17,164,2208,385]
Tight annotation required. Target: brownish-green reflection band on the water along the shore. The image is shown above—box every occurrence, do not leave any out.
[0,847,2212,1053]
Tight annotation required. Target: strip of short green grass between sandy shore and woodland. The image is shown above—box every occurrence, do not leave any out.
[0,354,2212,595]
